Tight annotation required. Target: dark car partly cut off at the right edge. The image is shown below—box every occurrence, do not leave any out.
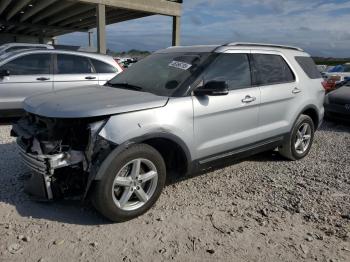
[324,80,350,122]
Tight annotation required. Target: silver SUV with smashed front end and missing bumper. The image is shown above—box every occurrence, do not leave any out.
[12,43,324,221]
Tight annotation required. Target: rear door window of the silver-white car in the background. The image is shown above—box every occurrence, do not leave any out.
[56,54,94,74]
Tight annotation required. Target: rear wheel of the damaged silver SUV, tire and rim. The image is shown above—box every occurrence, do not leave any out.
[278,115,315,161]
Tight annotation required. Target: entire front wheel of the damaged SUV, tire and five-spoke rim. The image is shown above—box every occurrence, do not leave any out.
[91,144,166,222]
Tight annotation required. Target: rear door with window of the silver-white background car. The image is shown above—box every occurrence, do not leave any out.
[54,54,98,90]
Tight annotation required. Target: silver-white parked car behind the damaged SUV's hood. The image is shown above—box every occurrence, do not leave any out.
[0,49,122,118]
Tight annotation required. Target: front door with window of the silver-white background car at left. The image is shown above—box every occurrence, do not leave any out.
[0,53,53,113]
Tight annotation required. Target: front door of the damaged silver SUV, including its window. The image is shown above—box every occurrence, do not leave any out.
[193,50,260,161]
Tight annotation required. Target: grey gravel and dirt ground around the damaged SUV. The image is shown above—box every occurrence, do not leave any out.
[0,123,350,262]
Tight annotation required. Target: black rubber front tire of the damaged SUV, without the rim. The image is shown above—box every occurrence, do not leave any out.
[92,144,166,222]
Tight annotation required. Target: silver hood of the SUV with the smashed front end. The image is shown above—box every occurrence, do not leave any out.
[23,86,168,118]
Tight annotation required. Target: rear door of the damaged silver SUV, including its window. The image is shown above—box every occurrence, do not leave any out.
[251,51,296,140]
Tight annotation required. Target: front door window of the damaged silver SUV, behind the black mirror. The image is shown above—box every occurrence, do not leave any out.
[203,54,251,90]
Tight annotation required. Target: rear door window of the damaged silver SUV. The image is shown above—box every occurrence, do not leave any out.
[252,54,295,85]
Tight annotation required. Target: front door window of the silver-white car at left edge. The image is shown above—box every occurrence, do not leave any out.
[0,54,51,75]
